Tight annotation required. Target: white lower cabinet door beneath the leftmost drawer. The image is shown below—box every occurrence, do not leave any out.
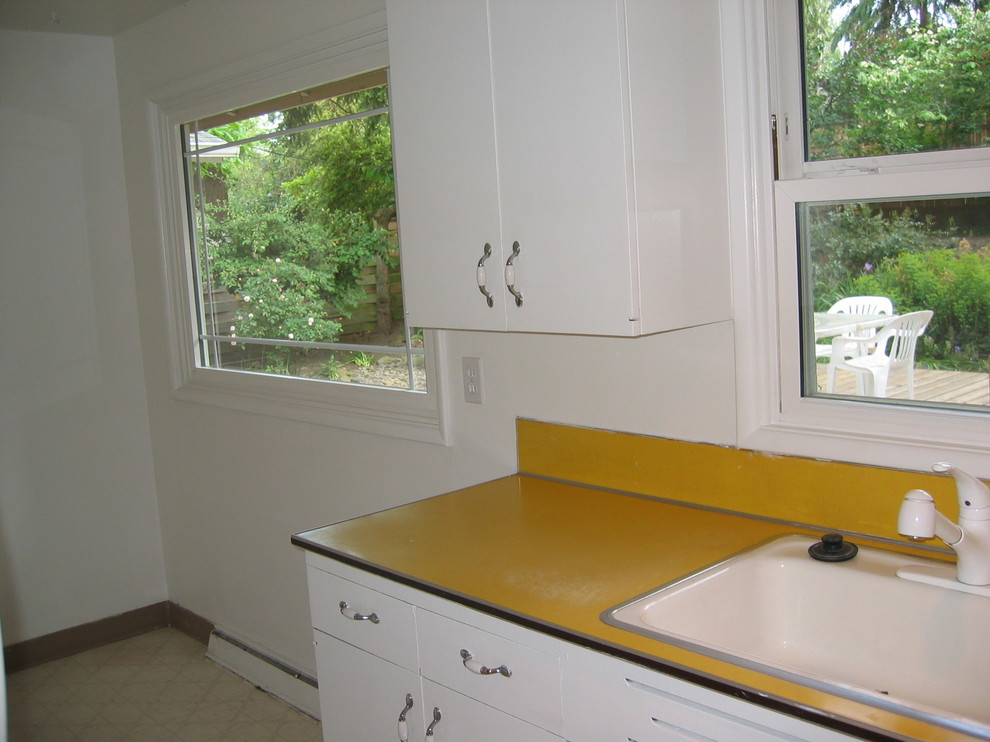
[314,631,426,742]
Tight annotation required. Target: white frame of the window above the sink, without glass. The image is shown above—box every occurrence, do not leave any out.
[721,0,990,477]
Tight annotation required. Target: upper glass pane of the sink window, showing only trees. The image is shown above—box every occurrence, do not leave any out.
[802,0,990,161]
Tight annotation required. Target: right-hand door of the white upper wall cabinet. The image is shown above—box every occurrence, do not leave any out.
[489,0,640,335]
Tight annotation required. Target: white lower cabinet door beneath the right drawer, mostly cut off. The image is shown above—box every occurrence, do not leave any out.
[423,680,561,742]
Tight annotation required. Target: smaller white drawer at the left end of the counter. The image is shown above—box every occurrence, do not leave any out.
[308,567,419,672]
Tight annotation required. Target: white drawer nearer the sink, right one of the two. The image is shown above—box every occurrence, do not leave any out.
[418,611,562,735]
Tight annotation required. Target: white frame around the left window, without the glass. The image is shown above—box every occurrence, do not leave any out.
[148,13,451,445]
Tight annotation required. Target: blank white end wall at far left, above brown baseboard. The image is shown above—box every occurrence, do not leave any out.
[0,31,167,643]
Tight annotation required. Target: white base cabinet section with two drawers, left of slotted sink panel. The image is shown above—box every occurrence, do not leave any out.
[307,555,562,742]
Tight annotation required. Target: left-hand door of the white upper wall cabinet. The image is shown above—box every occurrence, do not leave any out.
[387,0,506,330]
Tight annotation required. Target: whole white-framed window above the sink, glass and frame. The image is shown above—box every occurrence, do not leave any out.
[723,0,990,474]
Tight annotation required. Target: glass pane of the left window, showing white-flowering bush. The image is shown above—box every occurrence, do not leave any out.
[184,81,426,391]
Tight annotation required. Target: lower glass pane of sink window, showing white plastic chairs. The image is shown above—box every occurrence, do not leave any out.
[797,194,990,408]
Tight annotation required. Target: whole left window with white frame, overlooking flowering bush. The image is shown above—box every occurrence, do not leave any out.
[155,37,447,443]
